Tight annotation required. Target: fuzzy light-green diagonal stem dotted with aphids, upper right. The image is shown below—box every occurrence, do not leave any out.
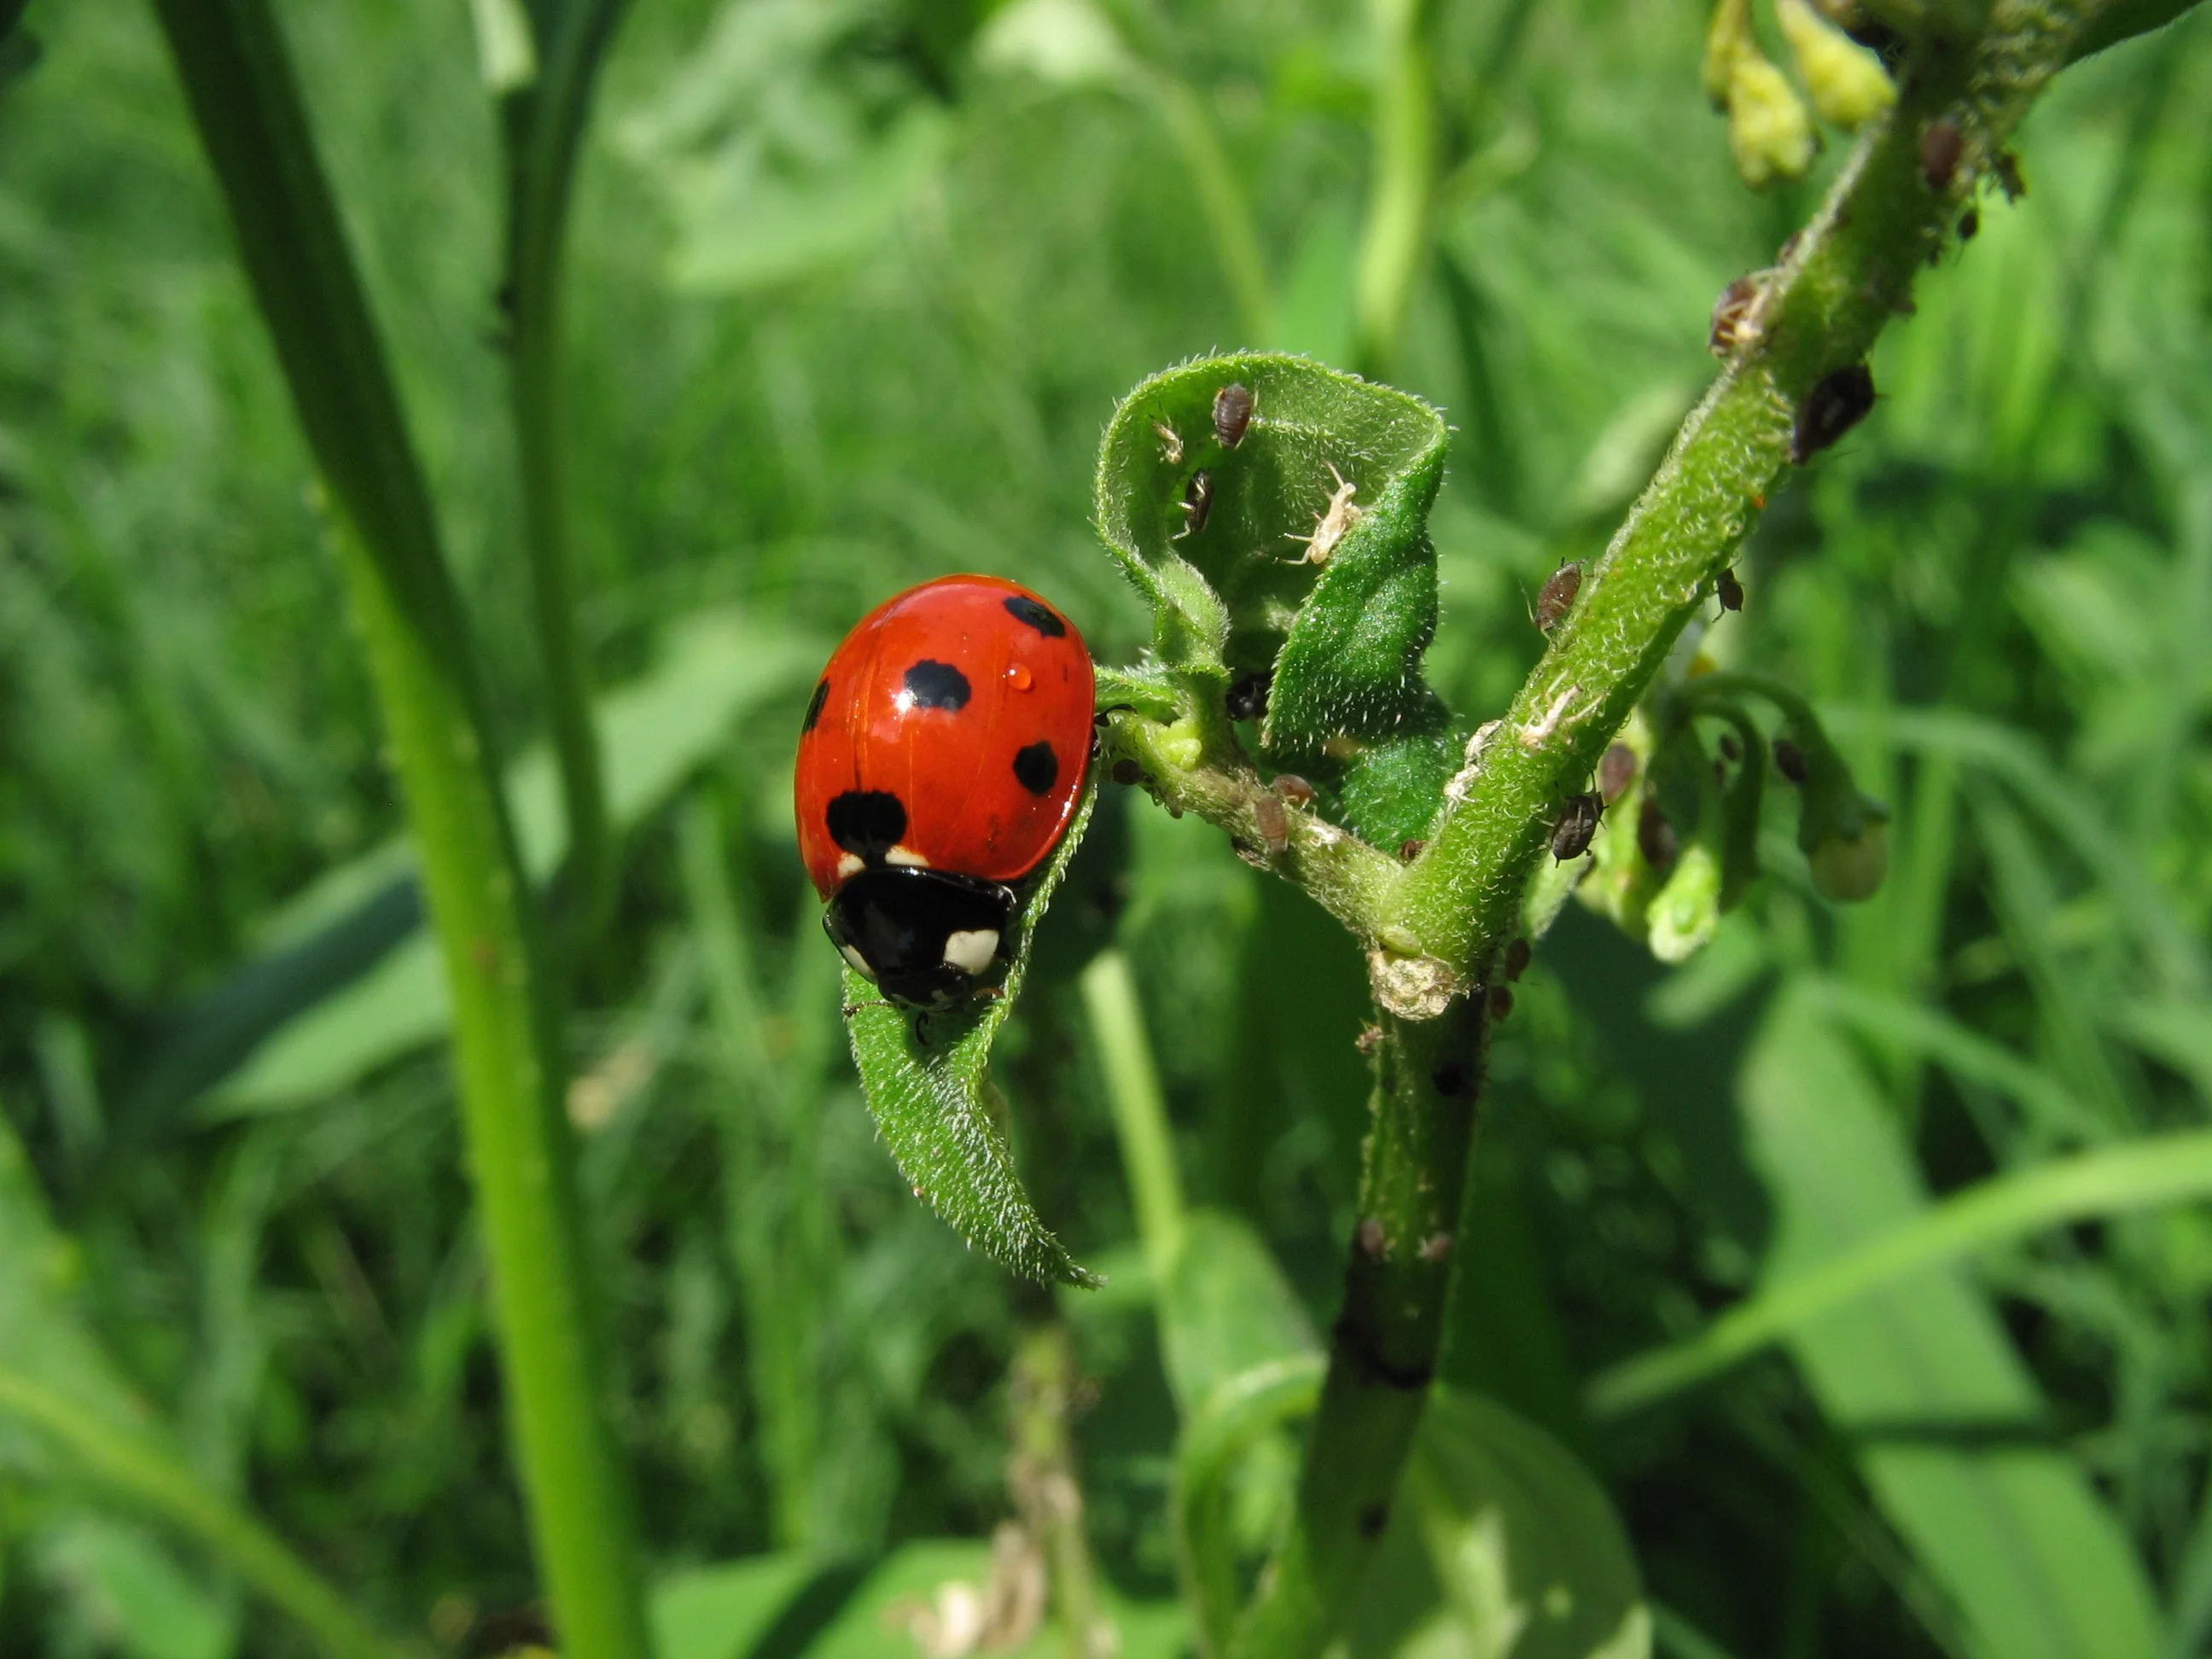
[1398,0,2090,978]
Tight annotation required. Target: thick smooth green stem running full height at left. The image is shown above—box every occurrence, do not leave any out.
[154,0,646,1659]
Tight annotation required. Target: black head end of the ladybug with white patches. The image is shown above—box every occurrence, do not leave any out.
[823,864,1013,1009]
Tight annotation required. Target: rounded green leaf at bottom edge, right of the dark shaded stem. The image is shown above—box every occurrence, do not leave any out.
[1352,1387,1652,1659]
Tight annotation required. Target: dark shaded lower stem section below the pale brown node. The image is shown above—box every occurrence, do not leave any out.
[1232,998,1487,1659]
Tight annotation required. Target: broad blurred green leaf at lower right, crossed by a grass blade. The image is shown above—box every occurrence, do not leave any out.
[1741,991,2161,1659]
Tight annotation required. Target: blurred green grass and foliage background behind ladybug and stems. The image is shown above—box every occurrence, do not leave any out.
[0,0,2212,1659]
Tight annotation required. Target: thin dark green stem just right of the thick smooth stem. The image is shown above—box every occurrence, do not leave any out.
[502,0,621,940]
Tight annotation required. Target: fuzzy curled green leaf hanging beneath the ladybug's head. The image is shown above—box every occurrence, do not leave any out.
[845,792,1097,1285]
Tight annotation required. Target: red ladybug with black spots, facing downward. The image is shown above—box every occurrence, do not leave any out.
[796,575,1095,1009]
